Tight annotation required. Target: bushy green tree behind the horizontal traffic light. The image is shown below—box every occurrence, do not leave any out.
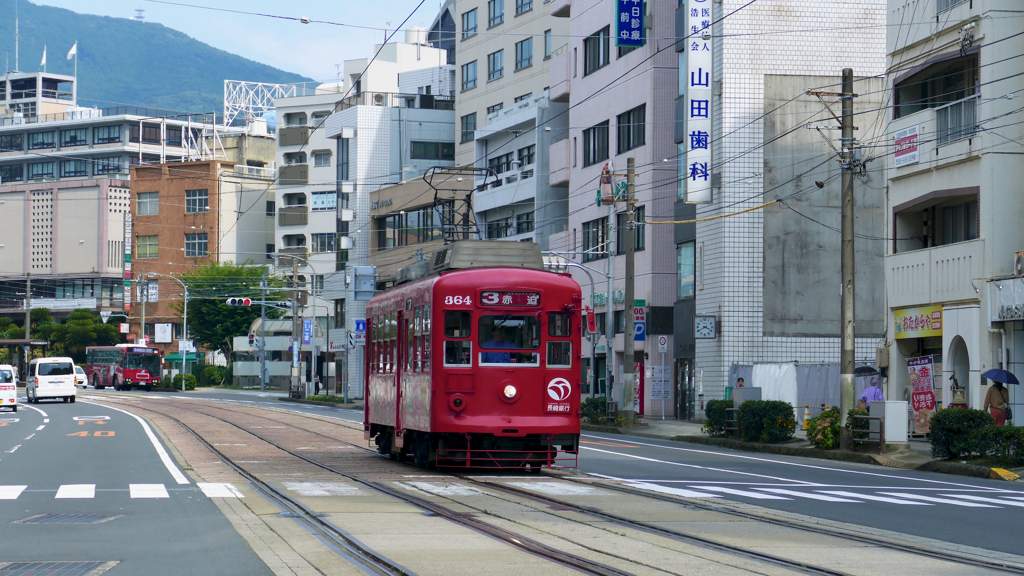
[171,261,285,358]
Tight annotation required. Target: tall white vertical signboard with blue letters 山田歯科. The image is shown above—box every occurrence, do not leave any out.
[684,0,715,203]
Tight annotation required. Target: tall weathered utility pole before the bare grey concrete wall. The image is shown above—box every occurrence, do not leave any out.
[839,68,855,450]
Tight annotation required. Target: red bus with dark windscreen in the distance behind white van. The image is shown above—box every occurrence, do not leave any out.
[85,344,161,390]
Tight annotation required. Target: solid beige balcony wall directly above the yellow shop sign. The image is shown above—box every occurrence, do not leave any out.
[886,239,985,307]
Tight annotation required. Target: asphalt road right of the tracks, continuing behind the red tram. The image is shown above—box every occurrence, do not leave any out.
[100,392,1024,553]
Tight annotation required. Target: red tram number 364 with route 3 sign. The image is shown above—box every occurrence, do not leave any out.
[364,241,582,472]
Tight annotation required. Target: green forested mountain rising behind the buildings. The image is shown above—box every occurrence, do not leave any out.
[0,0,309,114]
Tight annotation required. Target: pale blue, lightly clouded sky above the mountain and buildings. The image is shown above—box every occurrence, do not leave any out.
[30,0,440,82]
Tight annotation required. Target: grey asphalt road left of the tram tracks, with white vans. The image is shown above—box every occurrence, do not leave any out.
[0,391,271,575]
